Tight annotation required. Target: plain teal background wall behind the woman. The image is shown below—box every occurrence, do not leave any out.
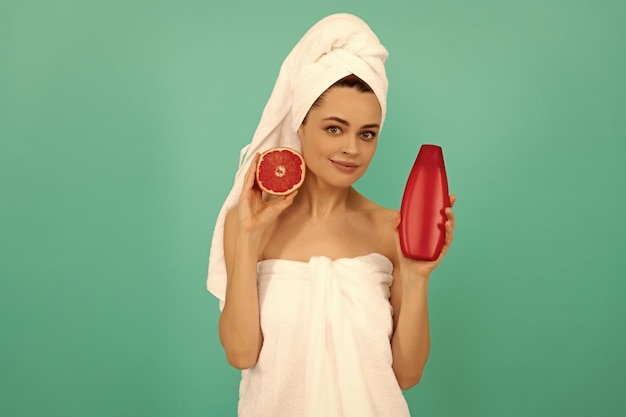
[0,0,626,417]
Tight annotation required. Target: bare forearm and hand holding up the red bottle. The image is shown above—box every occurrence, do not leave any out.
[391,196,455,390]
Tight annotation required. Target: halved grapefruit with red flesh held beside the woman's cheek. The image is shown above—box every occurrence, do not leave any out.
[256,147,306,195]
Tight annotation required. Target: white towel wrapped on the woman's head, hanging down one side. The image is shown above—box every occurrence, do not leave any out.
[207,13,388,309]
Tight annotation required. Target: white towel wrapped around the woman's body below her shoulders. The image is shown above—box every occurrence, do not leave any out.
[238,253,409,417]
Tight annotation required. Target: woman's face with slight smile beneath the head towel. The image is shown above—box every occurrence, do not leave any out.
[298,87,382,187]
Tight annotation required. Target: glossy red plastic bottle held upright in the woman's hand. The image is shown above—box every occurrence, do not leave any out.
[398,145,450,261]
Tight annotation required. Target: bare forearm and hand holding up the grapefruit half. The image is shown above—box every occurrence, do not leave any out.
[219,154,295,369]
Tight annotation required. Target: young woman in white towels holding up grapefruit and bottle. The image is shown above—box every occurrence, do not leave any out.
[209,15,454,417]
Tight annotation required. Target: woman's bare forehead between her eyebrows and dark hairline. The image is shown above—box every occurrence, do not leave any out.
[310,87,382,124]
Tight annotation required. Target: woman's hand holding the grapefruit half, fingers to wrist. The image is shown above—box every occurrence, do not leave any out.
[238,152,298,233]
